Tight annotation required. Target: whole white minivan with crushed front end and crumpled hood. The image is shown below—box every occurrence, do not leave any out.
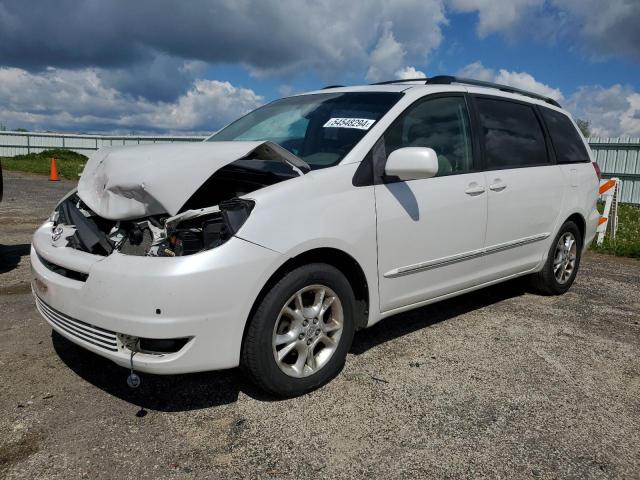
[31,76,600,396]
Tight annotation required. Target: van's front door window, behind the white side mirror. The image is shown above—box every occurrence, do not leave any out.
[384,97,473,176]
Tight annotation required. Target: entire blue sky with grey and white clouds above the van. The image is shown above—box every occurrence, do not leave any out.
[0,0,640,137]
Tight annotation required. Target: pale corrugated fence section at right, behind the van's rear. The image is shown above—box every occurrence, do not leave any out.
[589,137,640,205]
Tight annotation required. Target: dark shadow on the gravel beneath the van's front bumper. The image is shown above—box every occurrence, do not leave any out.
[51,331,277,412]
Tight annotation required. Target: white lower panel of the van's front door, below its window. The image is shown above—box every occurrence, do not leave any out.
[375,173,487,311]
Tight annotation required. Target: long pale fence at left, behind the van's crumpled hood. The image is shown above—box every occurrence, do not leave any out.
[0,132,205,157]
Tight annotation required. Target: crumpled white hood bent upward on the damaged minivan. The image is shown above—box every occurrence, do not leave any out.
[78,141,309,220]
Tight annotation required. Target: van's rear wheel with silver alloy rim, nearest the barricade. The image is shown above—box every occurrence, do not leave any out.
[531,221,582,295]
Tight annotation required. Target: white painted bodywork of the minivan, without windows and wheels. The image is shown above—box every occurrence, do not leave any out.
[31,85,599,374]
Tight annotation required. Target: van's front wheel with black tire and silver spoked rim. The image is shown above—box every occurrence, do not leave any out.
[241,263,355,397]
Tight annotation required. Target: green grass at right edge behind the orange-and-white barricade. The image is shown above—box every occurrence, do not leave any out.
[591,205,640,258]
